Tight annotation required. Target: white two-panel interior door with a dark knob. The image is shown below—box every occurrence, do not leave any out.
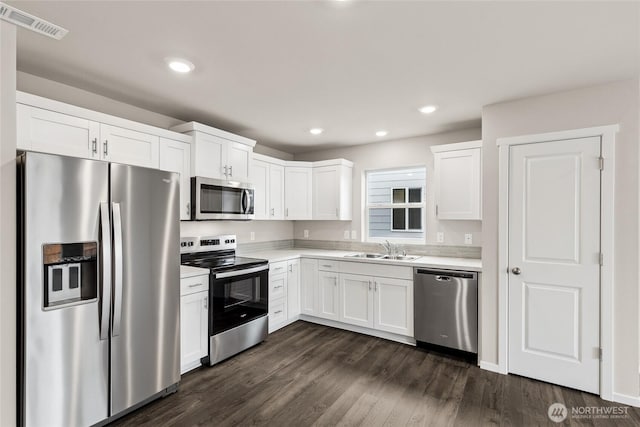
[508,137,600,393]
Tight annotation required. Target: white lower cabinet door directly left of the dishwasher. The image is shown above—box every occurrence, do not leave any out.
[373,277,413,337]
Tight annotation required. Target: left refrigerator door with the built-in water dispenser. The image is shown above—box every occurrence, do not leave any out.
[19,153,109,427]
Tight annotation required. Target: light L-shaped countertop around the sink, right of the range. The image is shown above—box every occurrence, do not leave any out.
[241,249,482,272]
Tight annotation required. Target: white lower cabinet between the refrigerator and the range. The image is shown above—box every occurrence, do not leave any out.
[180,274,209,374]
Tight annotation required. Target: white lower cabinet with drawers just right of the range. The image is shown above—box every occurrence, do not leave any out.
[269,259,300,333]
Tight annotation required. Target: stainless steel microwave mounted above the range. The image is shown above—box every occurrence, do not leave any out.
[191,176,255,221]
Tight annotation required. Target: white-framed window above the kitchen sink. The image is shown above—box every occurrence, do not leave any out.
[365,167,426,243]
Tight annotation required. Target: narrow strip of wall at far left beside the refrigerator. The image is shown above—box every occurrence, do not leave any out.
[0,21,16,426]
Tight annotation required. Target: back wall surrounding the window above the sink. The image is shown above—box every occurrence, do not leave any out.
[294,128,482,246]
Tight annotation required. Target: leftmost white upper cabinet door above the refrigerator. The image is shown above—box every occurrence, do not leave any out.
[16,104,100,158]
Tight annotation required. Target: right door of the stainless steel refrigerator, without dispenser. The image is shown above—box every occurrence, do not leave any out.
[111,163,180,415]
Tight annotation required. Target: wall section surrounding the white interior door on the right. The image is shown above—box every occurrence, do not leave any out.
[480,79,640,397]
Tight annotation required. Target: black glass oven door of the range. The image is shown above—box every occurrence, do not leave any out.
[209,264,269,335]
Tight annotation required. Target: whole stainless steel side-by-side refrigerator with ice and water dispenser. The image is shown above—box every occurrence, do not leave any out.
[18,152,180,427]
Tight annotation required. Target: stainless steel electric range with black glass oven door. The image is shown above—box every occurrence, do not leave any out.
[180,235,269,365]
